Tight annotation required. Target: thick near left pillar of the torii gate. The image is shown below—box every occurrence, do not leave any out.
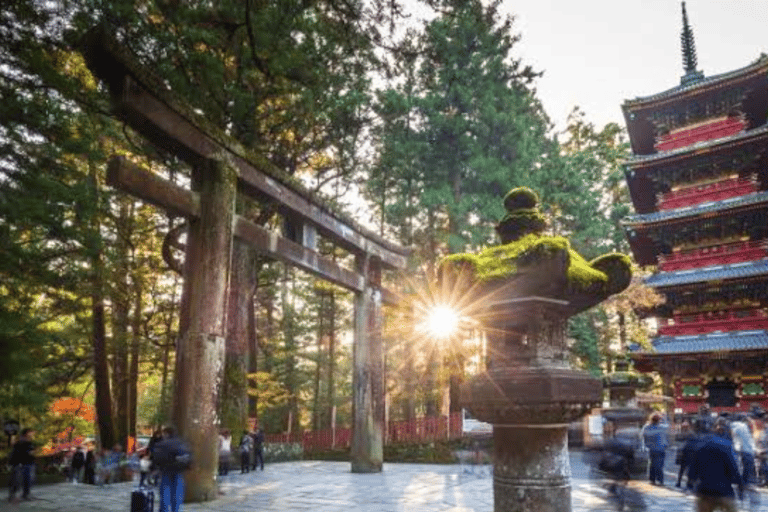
[173,154,237,501]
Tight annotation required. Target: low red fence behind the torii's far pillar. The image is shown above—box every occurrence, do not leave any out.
[265,412,462,452]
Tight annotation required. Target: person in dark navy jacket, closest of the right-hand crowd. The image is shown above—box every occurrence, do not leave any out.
[688,418,744,512]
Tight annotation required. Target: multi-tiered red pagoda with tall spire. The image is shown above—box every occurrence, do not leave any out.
[622,2,768,414]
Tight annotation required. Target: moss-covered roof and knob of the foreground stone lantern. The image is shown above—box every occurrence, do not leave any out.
[440,187,632,314]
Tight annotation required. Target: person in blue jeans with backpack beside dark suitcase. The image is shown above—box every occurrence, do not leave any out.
[154,427,192,512]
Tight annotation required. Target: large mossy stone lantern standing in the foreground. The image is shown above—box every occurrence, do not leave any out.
[441,188,631,512]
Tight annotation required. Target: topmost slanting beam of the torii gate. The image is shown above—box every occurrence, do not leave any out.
[85,25,411,284]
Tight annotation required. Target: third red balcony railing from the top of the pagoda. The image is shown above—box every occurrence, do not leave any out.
[658,240,768,272]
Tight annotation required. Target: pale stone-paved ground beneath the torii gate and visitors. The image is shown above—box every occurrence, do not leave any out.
[0,453,768,512]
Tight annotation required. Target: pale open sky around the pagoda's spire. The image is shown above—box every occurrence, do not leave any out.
[502,0,768,130]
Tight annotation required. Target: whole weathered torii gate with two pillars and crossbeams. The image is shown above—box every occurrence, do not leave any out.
[82,27,409,501]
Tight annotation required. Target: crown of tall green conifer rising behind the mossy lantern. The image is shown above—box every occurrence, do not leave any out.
[365,1,547,261]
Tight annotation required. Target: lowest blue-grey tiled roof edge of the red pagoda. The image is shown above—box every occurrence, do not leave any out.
[629,329,768,355]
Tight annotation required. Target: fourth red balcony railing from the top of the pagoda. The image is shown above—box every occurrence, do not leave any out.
[658,309,768,336]
